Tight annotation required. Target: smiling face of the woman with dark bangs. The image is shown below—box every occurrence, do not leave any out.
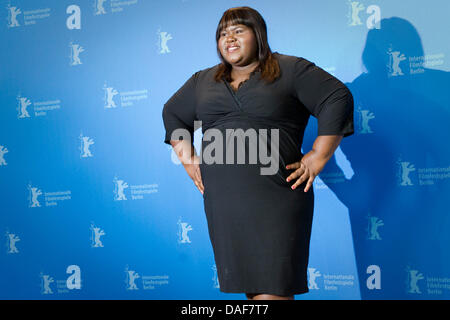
[218,24,258,66]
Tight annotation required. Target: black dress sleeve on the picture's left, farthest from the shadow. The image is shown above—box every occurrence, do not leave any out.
[162,72,199,144]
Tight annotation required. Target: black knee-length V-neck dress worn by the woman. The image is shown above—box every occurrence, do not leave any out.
[162,52,354,295]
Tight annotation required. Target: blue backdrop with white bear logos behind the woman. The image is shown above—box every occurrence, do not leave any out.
[0,0,450,299]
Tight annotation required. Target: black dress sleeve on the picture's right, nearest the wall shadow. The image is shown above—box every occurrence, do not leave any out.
[292,57,354,137]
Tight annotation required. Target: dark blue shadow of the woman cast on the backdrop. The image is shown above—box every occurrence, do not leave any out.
[305,17,450,300]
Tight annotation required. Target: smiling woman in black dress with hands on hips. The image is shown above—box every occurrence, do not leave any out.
[163,7,354,300]
